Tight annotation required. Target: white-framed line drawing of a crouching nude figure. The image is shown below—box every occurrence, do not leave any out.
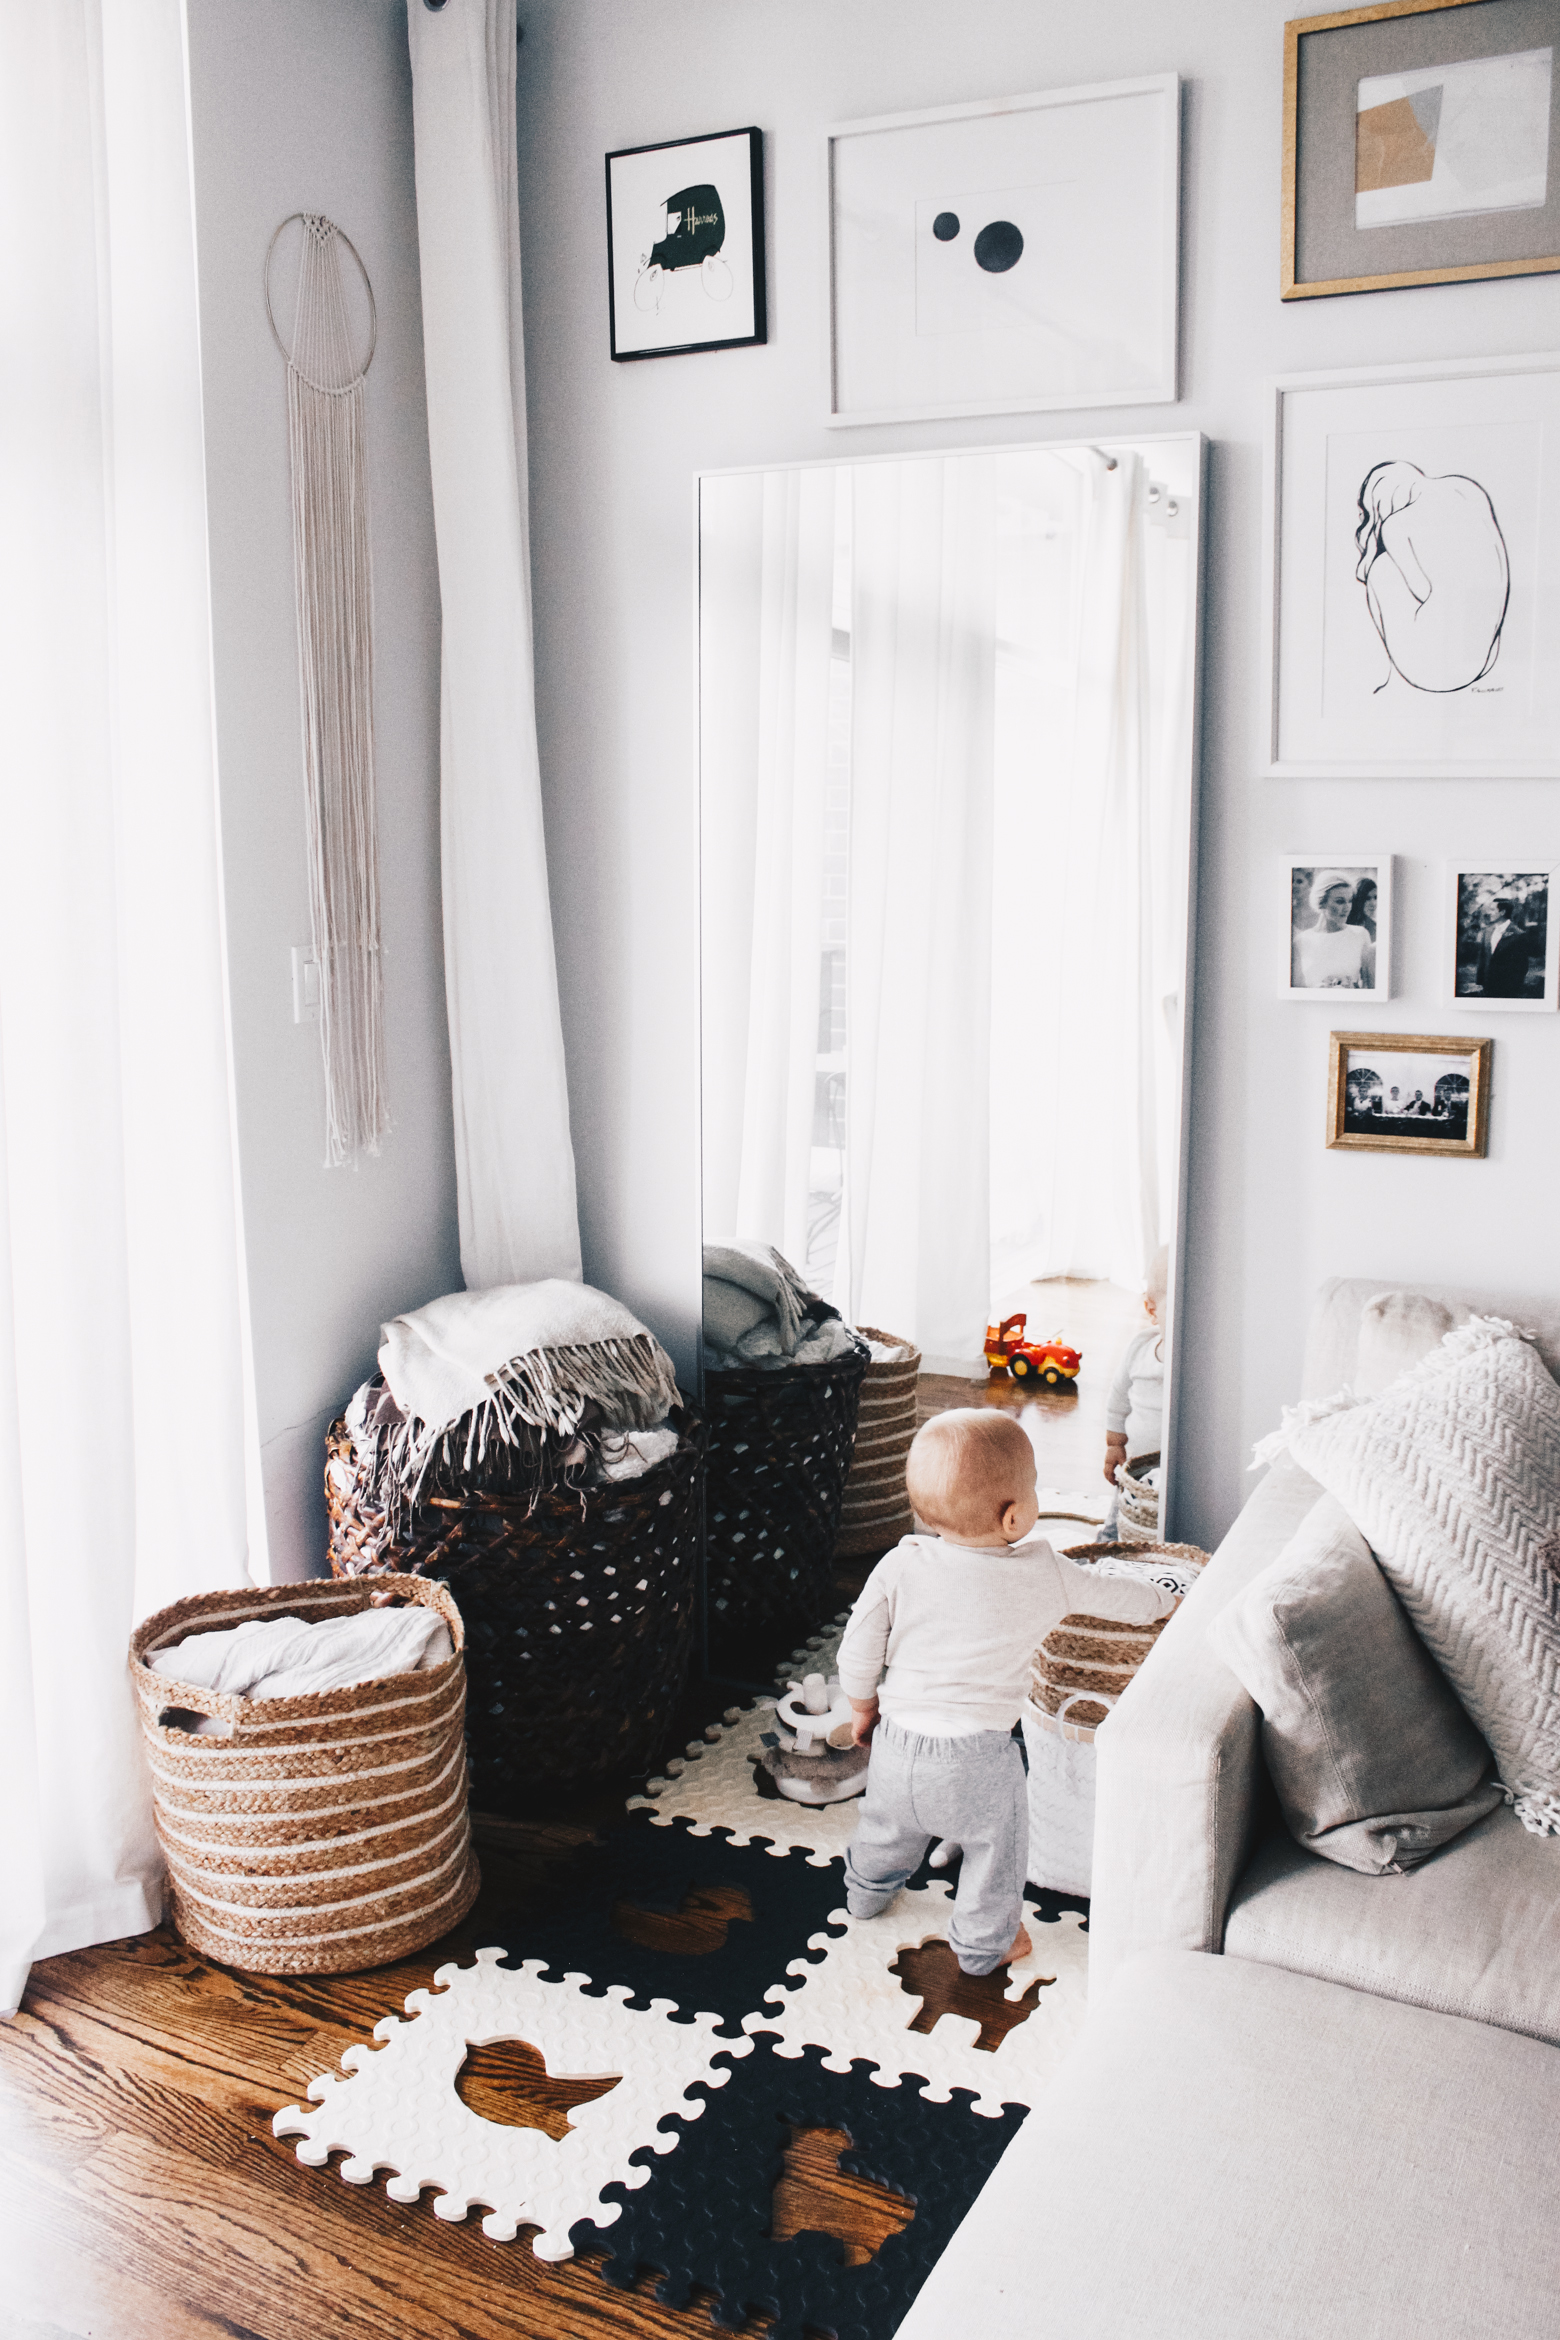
[1263,353,1560,779]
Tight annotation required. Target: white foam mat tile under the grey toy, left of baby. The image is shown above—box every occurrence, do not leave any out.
[629,1622,861,1870]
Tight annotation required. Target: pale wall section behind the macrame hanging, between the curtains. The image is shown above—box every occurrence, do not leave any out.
[187,0,461,1580]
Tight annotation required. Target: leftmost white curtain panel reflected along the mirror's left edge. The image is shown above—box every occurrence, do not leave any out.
[699,468,837,1266]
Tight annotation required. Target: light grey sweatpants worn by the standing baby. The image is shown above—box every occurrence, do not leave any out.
[844,1715,1029,1975]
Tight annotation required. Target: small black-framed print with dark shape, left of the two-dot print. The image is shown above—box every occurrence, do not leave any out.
[606,129,769,360]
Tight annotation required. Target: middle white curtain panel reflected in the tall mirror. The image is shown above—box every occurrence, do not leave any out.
[844,456,996,1369]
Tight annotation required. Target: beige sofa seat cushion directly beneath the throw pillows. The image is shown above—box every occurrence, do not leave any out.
[1223,1806,1560,2048]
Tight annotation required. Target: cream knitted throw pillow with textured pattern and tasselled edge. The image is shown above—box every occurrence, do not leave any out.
[1268,1317,1560,1835]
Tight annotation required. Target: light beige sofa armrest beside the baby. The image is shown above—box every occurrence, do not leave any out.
[1090,1458,1321,1991]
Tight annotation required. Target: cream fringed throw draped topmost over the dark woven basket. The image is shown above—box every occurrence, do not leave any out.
[379,1275,676,1432]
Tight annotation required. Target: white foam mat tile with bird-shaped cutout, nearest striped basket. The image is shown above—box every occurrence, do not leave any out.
[271,1938,748,2260]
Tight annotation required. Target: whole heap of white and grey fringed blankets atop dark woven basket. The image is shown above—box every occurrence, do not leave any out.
[362,1278,678,1519]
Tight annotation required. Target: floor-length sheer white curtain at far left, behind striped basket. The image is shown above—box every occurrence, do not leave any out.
[0,0,264,2010]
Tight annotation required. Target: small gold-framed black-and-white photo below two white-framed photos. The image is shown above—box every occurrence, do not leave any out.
[1326,1032,1495,1156]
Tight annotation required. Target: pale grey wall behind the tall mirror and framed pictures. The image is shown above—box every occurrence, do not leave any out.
[519,0,1560,1542]
